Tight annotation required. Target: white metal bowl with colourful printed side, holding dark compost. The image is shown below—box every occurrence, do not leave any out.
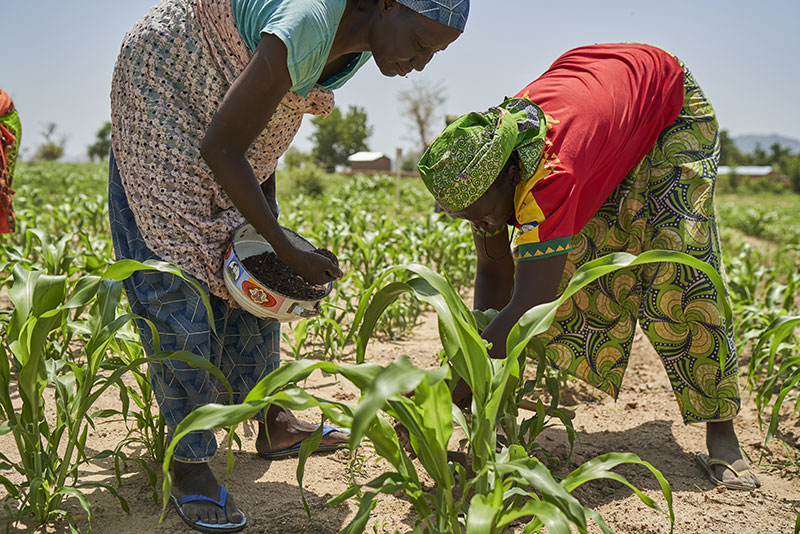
[223,224,333,323]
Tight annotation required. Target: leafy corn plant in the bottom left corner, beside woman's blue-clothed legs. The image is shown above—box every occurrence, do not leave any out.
[0,260,230,532]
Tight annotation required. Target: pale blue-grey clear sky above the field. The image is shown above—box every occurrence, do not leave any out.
[0,0,800,158]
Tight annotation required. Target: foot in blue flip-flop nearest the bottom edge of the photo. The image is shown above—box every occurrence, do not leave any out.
[172,460,243,524]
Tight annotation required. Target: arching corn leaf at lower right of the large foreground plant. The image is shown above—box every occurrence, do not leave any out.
[561,452,675,525]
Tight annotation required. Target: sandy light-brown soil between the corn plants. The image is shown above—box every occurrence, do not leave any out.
[0,314,800,534]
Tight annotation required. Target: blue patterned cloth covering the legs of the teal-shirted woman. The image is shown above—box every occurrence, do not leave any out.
[108,154,280,462]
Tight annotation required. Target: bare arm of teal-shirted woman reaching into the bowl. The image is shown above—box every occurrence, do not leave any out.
[200,34,341,284]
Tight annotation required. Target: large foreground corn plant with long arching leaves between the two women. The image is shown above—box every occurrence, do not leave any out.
[162,251,731,534]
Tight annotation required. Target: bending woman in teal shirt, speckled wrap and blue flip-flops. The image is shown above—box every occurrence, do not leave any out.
[109,0,469,532]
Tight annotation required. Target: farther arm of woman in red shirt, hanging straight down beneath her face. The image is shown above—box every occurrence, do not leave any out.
[472,228,514,310]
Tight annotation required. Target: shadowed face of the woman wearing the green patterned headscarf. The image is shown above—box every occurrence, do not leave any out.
[448,165,520,233]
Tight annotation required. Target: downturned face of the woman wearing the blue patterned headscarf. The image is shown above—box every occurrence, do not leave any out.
[369,0,461,76]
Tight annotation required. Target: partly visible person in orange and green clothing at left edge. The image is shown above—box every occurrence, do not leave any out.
[0,89,22,234]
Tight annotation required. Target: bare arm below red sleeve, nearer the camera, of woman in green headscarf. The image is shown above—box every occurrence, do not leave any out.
[481,254,567,358]
